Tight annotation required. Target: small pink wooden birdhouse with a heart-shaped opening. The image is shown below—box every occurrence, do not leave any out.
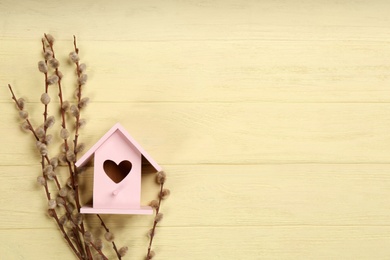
[76,123,161,214]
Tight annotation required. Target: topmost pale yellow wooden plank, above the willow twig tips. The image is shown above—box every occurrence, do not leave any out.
[0,0,390,41]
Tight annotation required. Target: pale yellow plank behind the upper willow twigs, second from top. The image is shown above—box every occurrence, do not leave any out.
[0,39,390,103]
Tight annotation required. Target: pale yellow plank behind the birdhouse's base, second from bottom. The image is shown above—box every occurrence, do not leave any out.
[0,164,390,229]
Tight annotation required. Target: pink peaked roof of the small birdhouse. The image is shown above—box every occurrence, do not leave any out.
[76,123,162,171]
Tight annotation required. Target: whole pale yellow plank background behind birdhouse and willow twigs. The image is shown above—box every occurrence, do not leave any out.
[0,0,390,260]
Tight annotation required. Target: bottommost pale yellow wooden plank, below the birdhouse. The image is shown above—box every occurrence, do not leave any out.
[0,226,390,260]
